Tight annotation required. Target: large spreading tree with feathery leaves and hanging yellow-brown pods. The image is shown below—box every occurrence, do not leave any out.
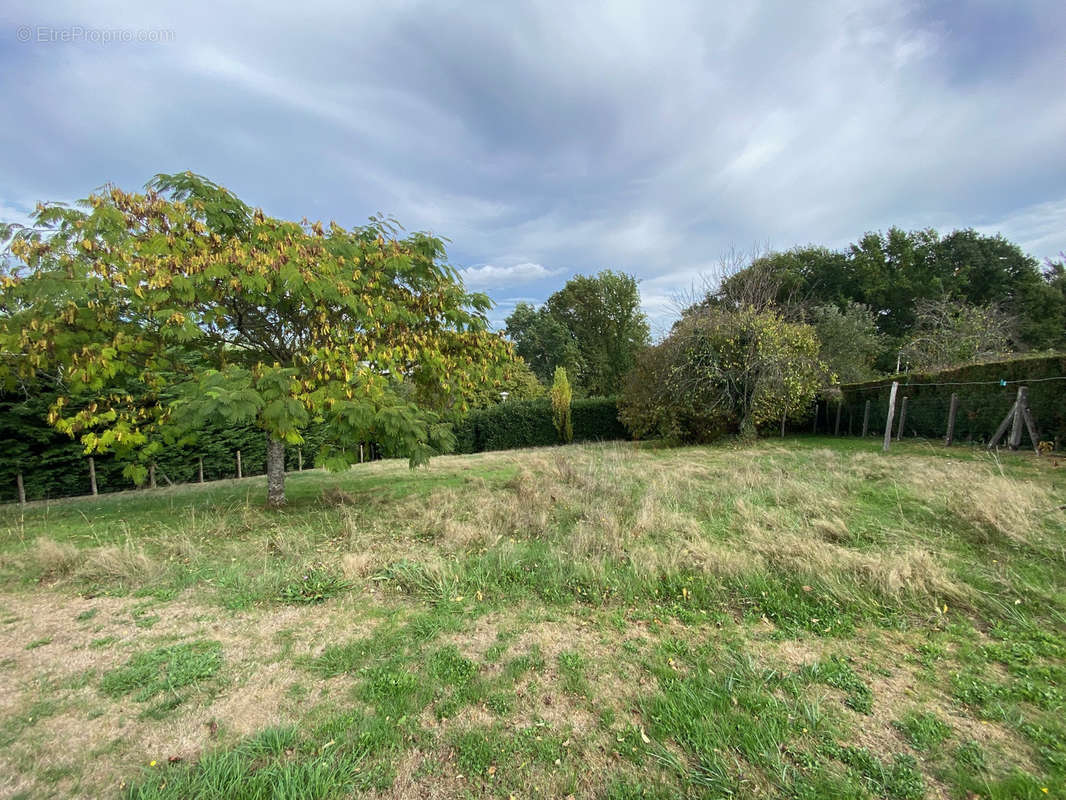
[0,173,507,506]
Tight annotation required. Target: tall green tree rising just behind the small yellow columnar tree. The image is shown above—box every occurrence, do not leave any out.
[547,270,649,396]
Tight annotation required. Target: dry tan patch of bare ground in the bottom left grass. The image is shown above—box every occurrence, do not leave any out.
[0,591,392,797]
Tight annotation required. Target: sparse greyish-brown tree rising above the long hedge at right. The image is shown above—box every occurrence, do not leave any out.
[901,300,1015,370]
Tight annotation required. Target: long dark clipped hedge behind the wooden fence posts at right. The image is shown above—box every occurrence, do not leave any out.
[835,354,1066,449]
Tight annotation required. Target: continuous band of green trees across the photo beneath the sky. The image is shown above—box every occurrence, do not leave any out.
[0,173,1066,506]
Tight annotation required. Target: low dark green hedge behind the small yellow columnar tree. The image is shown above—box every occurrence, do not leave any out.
[455,397,629,453]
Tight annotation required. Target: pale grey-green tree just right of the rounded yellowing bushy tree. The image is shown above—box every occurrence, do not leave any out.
[808,302,884,383]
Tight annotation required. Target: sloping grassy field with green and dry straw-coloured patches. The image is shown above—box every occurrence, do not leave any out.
[0,437,1066,800]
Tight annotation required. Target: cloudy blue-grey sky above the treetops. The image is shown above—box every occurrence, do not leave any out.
[0,0,1066,333]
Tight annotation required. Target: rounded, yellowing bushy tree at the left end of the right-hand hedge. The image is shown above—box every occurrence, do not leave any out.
[619,308,833,442]
